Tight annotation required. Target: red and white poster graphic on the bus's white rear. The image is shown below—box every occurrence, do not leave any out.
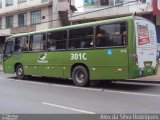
[137,25,150,45]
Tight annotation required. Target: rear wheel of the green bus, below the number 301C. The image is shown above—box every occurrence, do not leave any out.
[72,66,89,87]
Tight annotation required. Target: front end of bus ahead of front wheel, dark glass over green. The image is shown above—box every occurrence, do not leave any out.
[3,38,14,73]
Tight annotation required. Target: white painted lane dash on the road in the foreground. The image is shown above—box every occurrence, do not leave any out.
[41,102,96,114]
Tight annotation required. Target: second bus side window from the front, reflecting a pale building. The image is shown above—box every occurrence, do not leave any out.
[30,34,46,51]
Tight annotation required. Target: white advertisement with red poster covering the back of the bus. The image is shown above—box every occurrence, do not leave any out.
[135,20,157,68]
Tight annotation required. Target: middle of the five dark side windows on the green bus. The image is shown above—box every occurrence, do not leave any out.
[47,31,67,50]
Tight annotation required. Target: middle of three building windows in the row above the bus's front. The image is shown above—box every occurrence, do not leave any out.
[18,13,27,27]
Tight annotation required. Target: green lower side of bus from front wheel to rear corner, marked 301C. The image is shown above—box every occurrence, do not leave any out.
[23,47,128,80]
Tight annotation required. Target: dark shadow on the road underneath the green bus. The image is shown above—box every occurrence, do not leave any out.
[10,77,155,92]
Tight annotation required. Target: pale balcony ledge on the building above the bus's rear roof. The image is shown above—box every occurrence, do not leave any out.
[69,2,153,22]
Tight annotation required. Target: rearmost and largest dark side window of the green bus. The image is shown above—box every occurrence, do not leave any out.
[96,23,127,47]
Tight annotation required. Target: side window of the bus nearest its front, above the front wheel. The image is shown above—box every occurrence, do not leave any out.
[14,36,28,52]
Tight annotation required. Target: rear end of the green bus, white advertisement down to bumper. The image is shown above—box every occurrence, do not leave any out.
[134,17,157,77]
